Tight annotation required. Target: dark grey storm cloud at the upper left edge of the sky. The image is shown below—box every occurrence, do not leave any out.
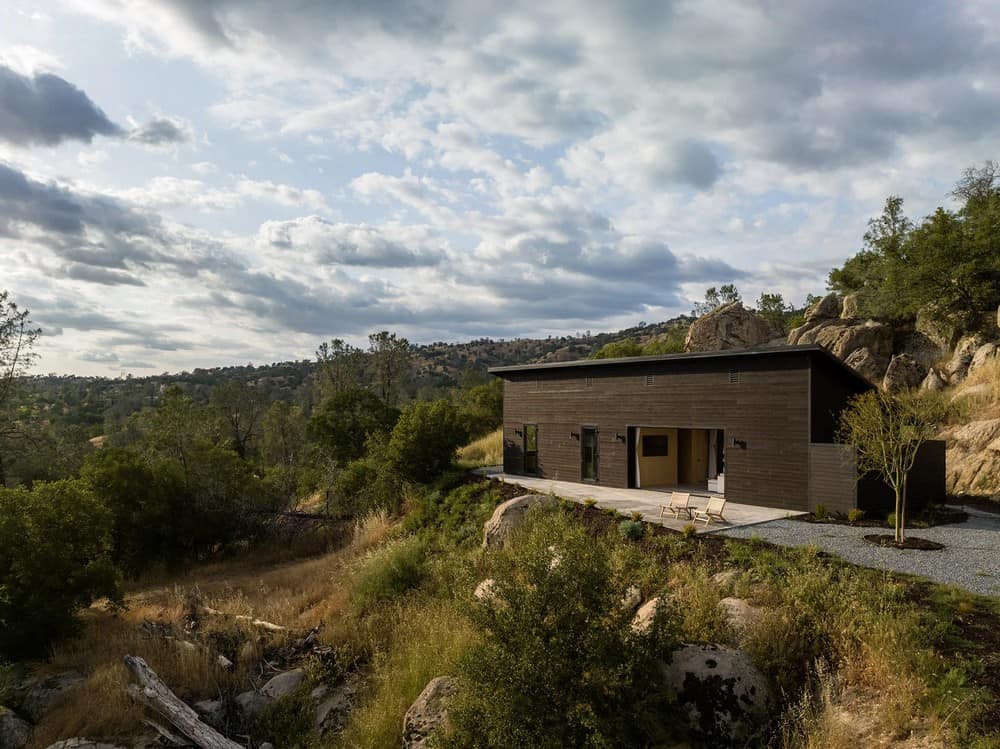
[0,65,122,146]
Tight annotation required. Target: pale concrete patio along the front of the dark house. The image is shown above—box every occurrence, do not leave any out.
[482,467,804,533]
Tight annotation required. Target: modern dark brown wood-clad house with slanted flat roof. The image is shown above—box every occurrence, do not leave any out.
[490,345,945,512]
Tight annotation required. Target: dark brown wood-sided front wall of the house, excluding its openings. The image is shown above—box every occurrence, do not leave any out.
[502,352,811,510]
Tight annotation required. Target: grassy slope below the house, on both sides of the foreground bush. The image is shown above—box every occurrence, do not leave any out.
[21,468,1000,749]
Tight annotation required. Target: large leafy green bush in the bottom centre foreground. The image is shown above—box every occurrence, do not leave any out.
[445,508,673,749]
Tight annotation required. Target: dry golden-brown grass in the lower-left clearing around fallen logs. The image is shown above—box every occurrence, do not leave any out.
[29,515,404,749]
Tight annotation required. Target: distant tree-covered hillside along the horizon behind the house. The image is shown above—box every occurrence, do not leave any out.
[26,315,693,434]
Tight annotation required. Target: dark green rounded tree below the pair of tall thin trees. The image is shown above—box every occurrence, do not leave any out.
[308,388,399,465]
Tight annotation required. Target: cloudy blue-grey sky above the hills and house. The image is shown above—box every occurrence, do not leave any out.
[0,0,1000,376]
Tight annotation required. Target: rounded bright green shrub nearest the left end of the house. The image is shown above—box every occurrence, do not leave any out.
[386,400,466,483]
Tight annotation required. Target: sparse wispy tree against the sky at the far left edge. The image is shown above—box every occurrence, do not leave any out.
[0,290,41,487]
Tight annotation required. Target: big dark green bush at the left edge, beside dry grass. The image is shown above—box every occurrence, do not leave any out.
[0,480,119,659]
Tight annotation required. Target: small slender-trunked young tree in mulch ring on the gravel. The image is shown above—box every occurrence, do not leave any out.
[838,390,944,541]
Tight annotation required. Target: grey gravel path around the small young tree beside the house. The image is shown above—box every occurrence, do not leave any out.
[717,509,1000,596]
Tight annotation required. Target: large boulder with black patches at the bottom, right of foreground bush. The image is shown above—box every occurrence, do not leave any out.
[661,645,771,746]
